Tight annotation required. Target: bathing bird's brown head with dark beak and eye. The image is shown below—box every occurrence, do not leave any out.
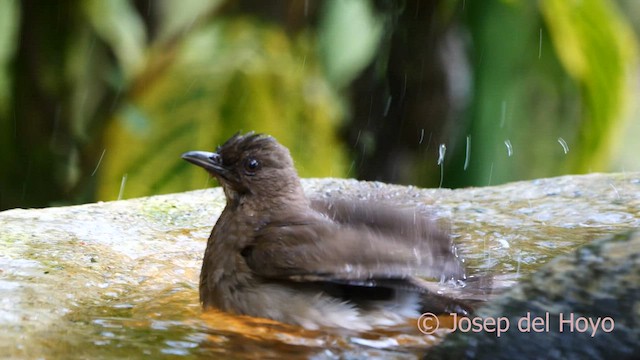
[182,132,303,207]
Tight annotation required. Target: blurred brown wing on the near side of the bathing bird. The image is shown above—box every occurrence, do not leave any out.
[242,208,464,285]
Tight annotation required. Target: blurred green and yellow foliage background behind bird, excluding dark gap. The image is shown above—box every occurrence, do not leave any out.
[0,0,640,209]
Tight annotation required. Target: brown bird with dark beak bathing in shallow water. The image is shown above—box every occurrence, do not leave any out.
[182,133,468,330]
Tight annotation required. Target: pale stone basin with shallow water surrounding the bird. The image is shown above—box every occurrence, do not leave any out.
[0,175,640,359]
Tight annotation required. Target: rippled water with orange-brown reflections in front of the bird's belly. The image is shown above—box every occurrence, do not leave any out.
[56,286,452,359]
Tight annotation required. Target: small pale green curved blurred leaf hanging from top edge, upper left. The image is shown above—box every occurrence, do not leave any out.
[81,0,146,80]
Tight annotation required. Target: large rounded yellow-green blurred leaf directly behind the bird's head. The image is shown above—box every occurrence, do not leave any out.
[99,19,346,199]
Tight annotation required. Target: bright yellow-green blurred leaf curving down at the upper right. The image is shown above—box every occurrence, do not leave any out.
[540,0,637,172]
